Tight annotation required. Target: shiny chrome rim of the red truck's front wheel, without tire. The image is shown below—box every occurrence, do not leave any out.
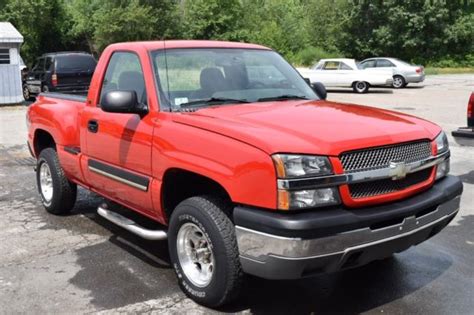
[176,223,215,288]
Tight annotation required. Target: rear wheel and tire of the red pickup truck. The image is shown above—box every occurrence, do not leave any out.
[36,148,77,215]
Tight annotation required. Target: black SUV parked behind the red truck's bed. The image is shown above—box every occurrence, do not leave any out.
[23,51,97,100]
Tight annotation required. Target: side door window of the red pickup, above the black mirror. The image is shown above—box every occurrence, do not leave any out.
[100,52,147,104]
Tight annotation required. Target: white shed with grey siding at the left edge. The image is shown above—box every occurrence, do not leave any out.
[0,22,23,105]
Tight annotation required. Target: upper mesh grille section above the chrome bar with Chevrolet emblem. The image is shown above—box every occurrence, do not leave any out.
[339,141,432,172]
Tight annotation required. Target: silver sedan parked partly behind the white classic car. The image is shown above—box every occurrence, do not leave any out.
[359,58,425,89]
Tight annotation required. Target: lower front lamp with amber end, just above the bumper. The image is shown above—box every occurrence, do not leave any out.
[278,187,340,210]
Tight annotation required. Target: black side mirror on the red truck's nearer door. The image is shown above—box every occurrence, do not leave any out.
[100,91,146,115]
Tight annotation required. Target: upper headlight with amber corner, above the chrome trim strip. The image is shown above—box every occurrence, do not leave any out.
[272,154,332,178]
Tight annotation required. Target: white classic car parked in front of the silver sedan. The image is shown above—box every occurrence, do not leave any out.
[297,58,393,93]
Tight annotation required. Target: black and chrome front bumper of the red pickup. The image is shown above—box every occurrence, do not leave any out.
[234,176,462,279]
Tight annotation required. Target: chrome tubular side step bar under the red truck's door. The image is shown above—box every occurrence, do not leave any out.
[97,207,168,241]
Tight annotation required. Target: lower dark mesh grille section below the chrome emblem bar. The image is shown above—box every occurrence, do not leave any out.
[349,167,433,199]
